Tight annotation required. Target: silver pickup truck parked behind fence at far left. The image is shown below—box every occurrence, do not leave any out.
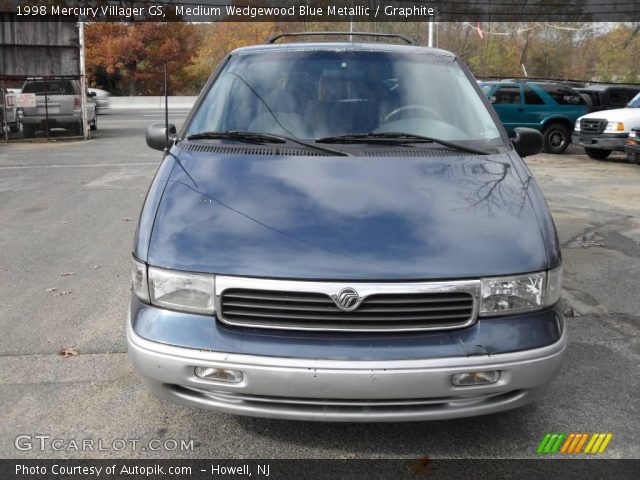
[18,78,98,138]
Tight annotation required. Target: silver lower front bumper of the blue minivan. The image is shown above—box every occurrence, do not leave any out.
[127,321,567,422]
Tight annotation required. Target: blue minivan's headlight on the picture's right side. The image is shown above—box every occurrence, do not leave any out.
[480,267,562,316]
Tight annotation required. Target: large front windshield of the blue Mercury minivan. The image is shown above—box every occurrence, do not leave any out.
[186,49,503,147]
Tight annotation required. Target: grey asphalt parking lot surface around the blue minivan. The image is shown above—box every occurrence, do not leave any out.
[0,110,640,458]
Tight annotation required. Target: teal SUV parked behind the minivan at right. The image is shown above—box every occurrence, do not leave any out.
[482,81,587,153]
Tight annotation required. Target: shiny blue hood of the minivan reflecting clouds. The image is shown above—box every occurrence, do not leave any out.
[148,147,548,280]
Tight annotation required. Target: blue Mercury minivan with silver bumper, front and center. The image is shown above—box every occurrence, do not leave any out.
[126,33,567,421]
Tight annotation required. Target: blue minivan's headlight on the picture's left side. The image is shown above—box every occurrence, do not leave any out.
[149,267,215,315]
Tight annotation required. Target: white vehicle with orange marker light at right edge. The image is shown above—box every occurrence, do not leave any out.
[572,89,640,160]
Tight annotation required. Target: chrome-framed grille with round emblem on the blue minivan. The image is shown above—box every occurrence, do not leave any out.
[216,277,476,331]
